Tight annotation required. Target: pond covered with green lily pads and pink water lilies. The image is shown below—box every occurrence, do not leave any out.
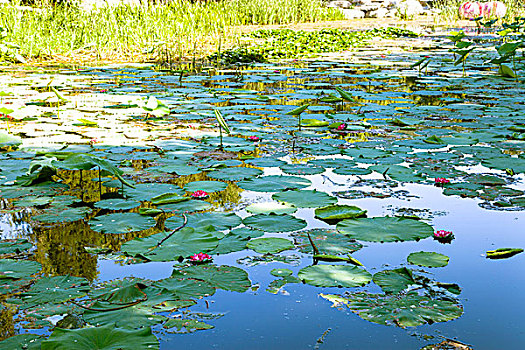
[0,30,525,349]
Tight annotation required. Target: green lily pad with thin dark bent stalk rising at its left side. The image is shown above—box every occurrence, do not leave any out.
[292,228,363,255]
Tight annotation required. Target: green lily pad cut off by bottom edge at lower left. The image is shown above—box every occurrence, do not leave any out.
[42,325,159,350]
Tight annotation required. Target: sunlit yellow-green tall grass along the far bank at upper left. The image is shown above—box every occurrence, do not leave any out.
[0,0,342,61]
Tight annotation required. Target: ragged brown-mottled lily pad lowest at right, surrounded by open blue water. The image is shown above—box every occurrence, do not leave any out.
[320,292,463,328]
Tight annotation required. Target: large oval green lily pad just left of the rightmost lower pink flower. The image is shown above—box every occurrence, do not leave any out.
[337,216,434,242]
